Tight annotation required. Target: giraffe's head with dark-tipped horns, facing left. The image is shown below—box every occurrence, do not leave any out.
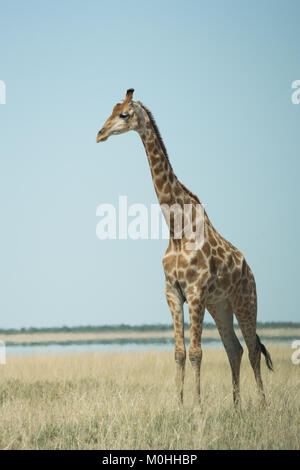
[96,88,140,142]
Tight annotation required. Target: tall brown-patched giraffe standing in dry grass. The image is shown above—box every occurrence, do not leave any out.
[96,88,273,407]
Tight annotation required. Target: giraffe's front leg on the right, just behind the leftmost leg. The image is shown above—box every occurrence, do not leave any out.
[188,298,205,406]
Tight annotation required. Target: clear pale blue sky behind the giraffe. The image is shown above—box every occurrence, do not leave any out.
[0,0,300,328]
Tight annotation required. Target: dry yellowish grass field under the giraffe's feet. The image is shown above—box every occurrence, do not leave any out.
[0,346,300,450]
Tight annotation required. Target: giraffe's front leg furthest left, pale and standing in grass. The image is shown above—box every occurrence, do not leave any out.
[166,281,186,404]
